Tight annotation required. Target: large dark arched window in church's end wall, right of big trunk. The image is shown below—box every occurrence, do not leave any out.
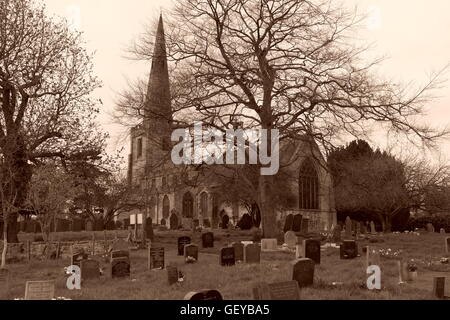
[298,159,319,210]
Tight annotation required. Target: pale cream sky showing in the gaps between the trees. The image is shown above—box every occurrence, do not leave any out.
[43,0,450,159]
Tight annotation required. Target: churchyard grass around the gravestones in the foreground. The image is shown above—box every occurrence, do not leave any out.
[6,231,450,300]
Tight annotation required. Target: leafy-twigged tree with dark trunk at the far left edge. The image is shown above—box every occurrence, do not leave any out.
[0,0,105,242]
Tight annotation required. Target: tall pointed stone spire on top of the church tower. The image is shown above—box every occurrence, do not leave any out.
[145,14,172,130]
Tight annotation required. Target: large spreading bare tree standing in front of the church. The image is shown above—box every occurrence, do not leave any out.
[122,0,446,237]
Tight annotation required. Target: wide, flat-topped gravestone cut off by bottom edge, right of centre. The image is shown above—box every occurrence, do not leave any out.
[253,280,300,300]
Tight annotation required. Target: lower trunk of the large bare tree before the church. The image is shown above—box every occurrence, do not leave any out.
[259,175,278,239]
